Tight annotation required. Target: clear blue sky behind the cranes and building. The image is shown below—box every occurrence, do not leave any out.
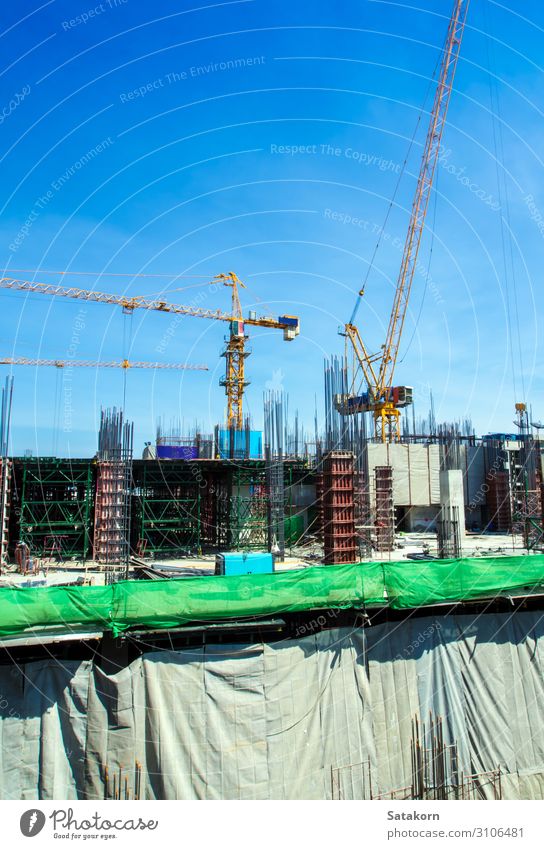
[0,0,544,456]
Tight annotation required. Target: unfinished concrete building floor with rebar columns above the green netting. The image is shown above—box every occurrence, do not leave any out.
[1,390,543,566]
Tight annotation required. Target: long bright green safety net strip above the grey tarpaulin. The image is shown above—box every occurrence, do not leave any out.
[0,554,544,637]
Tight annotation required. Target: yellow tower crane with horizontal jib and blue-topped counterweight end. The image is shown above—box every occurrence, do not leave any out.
[0,271,300,429]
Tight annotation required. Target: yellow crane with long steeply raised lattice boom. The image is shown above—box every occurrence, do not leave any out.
[335,0,470,442]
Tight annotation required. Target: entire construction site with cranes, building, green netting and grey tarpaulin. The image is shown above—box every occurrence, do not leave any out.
[0,0,544,800]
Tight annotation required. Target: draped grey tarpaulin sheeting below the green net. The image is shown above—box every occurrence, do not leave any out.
[0,612,544,800]
